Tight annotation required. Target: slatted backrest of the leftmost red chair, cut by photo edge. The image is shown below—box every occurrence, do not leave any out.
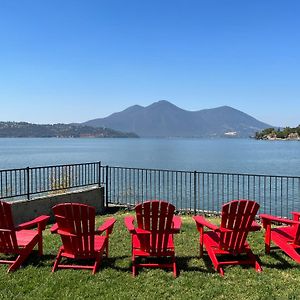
[0,201,19,253]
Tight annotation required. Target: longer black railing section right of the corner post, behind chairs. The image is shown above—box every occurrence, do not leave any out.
[101,166,300,217]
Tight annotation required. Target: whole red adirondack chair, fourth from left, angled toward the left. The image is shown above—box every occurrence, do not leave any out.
[194,200,262,276]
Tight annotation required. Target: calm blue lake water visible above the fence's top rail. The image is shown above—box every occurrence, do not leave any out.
[0,138,300,176]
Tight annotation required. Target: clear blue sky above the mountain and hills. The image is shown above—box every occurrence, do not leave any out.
[0,0,300,126]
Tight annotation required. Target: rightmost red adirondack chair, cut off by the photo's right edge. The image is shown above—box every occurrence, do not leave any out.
[260,212,300,263]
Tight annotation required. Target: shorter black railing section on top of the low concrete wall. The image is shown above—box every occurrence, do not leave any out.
[0,162,101,200]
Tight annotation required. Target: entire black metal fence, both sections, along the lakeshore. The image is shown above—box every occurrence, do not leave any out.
[0,162,300,217]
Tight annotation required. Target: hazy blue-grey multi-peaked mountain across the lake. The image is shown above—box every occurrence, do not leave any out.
[83,100,270,137]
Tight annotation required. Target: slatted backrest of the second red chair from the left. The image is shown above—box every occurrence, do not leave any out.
[53,203,95,258]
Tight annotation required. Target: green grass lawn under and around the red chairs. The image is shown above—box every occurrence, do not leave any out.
[0,211,300,299]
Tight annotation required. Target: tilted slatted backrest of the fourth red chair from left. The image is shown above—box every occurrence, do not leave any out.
[220,200,259,253]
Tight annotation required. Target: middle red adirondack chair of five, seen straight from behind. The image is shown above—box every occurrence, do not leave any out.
[125,200,181,277]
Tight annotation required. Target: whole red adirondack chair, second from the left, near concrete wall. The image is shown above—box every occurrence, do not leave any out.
[51,203,116,274]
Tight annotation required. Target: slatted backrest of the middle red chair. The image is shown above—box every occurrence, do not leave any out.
[135,200,175,255]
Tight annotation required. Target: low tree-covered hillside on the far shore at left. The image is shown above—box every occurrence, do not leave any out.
[0,122,137,138]
